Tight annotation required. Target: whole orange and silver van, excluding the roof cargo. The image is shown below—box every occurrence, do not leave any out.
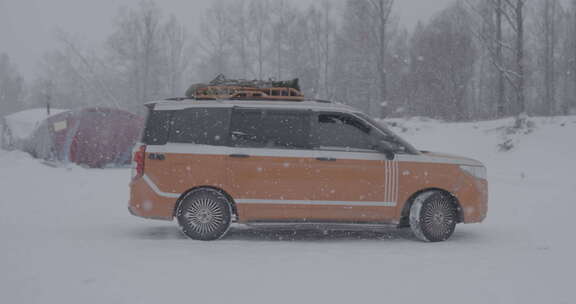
[129,100,488,242]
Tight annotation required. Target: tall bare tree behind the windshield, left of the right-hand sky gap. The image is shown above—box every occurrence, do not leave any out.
[333,0,397,116]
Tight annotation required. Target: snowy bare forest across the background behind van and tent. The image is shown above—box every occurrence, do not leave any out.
[0,0,576,121]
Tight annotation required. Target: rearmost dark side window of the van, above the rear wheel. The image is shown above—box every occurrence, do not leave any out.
[170,108,230,146]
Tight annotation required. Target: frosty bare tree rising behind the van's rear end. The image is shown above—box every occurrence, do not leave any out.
[107,1,190,112]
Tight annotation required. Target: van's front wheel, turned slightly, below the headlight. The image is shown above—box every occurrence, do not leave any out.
[410,191,458,242]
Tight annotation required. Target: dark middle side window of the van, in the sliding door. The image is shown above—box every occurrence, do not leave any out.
[230,109,310,149]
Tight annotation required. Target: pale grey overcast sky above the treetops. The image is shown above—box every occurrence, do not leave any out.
[0,0,452,78]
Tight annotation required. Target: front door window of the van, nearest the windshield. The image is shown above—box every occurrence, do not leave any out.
[314,113,374,152]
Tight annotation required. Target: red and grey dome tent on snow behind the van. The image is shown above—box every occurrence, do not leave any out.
[4,108,143,168]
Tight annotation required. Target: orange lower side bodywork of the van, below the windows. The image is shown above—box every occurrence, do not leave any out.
[131,147,487,223]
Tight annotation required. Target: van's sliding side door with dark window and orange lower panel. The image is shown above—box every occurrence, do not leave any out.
[227,109,313,222]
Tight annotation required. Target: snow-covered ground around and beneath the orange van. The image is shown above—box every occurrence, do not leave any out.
[0,117,576,304]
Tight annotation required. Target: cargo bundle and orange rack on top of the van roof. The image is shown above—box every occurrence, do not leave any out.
[186,75,304,101]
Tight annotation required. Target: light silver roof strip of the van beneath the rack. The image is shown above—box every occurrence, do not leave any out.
[151,98,360,113]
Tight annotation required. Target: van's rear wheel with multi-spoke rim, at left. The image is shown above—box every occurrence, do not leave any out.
[176,189,232,241]
